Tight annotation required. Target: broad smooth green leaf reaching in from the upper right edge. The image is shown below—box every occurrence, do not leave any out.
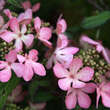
[81,11,110,29]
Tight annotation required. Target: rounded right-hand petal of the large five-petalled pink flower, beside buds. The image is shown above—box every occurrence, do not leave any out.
[77,67,94,81]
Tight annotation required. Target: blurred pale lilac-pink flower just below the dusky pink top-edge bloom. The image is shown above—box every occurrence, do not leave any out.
[17,9,32,25]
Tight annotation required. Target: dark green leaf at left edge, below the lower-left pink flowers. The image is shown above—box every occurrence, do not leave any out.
[0,75,20,110]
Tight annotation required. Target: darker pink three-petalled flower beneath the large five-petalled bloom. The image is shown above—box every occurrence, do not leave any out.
[65,83,96,110]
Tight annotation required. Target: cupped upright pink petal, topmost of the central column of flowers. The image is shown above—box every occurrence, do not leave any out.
[57,19,67,34]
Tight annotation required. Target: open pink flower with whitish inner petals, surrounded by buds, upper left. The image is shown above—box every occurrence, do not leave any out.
[0,18,34,52]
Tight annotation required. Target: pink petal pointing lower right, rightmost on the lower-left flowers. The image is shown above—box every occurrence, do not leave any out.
[32,62,46,76]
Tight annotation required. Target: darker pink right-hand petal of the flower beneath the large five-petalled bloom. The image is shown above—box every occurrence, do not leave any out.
[81,83,96,93]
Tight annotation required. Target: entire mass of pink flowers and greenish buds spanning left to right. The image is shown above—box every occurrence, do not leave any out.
[0,1,110,109]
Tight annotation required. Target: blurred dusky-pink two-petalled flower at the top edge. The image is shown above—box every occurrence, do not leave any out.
[22,0,40,12]
